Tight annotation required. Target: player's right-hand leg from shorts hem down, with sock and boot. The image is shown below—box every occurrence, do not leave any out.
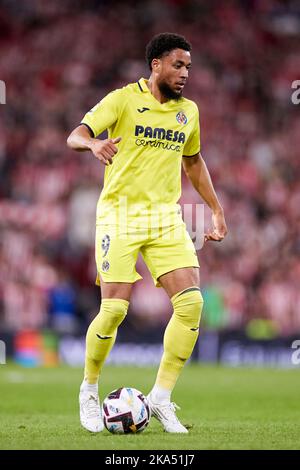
[149,268,203,433]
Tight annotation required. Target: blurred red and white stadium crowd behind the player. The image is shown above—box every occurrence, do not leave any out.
[0,0,300,336]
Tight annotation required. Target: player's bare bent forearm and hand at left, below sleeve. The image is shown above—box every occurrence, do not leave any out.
[67,124,121,165]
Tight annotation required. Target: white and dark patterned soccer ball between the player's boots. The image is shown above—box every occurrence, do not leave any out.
[102,387,150,434]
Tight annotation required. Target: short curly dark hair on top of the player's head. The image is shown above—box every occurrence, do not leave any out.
[146,33,192,70]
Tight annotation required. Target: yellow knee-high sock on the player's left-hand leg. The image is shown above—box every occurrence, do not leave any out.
[84,299,129,384]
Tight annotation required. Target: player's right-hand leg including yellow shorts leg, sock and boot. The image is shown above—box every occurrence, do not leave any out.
[143,226,203,433]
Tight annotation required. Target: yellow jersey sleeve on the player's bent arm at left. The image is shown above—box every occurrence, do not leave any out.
[81,89,122,137]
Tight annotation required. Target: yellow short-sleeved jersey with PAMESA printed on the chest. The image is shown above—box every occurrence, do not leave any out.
[81,78,200,226]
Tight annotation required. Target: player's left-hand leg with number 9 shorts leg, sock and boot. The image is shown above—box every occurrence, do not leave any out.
[79,227,141,432]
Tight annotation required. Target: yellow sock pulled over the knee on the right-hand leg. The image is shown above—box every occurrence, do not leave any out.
[155,287,203,391]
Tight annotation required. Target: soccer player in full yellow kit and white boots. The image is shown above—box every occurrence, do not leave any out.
[68,33,227,433]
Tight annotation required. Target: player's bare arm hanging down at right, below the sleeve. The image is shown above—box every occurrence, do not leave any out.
[182,152,227,241]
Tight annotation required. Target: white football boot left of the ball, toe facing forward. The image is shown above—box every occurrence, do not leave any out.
[79,381,104,432]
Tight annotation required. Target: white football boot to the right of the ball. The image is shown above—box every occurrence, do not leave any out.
[147,394,188,434]
